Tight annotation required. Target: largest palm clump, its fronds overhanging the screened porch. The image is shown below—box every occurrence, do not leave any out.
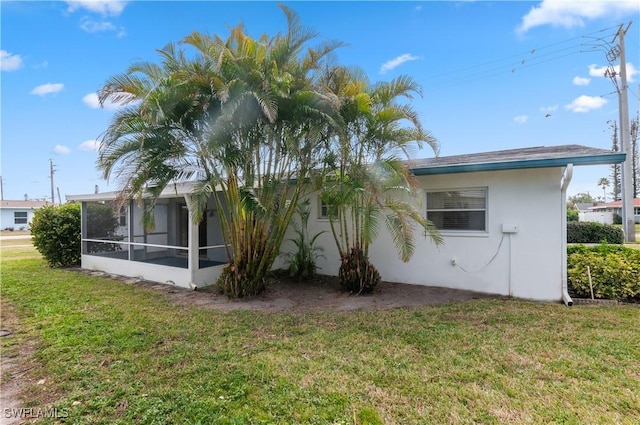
[99,6,341,297]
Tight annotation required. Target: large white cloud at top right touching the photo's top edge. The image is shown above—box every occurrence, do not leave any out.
[516,0,640,33]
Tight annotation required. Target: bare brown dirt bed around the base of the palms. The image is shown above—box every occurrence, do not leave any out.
[78,269,501,313]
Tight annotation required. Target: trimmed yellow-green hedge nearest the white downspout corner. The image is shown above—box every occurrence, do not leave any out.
[567,244,640,301]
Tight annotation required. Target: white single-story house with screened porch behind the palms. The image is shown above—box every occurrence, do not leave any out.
[68,145,625,305]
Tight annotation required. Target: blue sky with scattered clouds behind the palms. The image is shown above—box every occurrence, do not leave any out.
[0,0,640,201]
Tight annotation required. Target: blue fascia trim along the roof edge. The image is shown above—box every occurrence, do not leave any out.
[411,153,627,176]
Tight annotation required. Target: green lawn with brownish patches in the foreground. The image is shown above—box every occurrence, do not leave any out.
[0,253,640,424]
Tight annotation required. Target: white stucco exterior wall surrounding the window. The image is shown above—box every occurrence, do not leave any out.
[309,168,564,301]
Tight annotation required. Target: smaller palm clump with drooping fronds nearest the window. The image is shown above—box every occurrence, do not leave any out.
[321,67,441,293]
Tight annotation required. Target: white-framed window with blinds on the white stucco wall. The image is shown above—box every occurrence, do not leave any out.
[427,187,487,232]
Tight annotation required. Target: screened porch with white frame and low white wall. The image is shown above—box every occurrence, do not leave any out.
[67,185,227,289]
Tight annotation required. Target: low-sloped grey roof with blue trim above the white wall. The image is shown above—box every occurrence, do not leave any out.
[411,145,626,176]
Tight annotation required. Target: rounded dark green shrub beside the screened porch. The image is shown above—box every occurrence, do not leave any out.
[31,203,80,267]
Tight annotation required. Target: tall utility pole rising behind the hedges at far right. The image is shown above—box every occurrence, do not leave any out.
[611,22,636,242]
